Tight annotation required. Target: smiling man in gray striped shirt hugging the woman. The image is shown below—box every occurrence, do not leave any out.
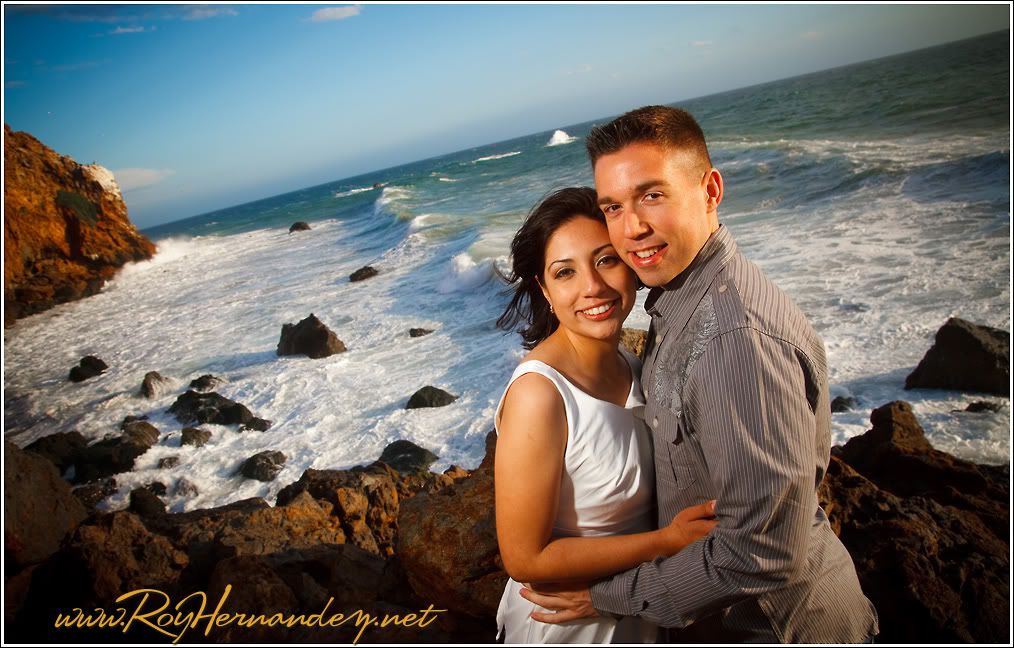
[521,106,878,643]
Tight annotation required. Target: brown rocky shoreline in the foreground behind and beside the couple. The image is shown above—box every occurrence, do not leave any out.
[4,324,1010,643]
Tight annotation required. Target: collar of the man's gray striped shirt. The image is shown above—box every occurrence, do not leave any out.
[644,225,736,331]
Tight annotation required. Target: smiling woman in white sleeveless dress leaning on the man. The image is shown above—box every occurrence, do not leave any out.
[495,188,715,643]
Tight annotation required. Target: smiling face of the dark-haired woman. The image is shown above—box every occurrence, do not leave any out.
[542,216,637,340]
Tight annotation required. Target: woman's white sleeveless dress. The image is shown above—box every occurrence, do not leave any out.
[494,349,658,644]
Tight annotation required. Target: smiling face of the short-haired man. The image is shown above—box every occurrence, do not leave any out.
[594,142,722,286]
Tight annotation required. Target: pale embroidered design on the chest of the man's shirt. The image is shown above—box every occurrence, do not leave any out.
[654,295,718,418]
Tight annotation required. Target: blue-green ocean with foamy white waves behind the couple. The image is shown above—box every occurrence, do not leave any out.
[4,31,1011,511]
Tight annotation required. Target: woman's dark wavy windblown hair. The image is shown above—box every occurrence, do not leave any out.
[497,187,605,350]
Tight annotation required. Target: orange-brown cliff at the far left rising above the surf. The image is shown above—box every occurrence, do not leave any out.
[3,124,155,326]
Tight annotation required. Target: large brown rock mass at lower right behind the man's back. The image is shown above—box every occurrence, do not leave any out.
[818,402,1010,644]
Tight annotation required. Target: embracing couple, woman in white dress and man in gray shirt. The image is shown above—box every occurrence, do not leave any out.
[495,106,877,643]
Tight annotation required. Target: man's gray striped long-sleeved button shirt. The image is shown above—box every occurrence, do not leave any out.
[591,226,878,643]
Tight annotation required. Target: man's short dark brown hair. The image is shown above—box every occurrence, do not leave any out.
[585,105,711,168]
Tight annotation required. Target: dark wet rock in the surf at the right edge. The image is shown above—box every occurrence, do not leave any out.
[904,317,1011,397]
